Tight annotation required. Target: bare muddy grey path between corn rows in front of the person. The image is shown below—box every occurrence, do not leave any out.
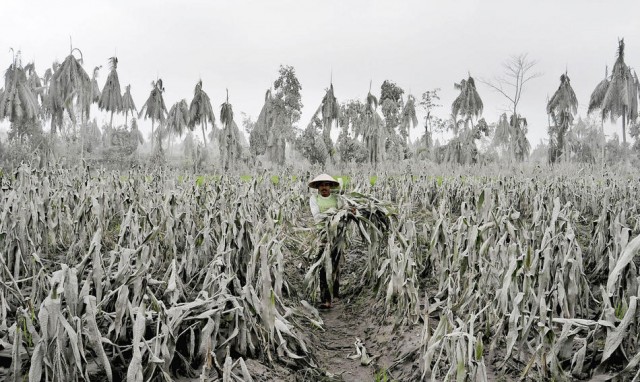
[280,247,424,381]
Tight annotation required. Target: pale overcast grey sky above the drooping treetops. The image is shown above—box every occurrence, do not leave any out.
[0,0,640,147]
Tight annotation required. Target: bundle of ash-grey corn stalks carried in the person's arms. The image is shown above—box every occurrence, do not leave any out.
[304,191,419,324]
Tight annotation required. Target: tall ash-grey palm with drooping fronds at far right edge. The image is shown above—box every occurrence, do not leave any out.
[588,39,639,146]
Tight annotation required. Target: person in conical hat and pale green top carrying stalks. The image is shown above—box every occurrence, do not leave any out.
[309,174,348,309]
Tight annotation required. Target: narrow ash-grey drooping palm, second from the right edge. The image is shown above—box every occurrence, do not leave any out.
[547,73,578,163]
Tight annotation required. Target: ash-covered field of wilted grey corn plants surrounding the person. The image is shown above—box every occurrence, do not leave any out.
[0,165,640,382]
